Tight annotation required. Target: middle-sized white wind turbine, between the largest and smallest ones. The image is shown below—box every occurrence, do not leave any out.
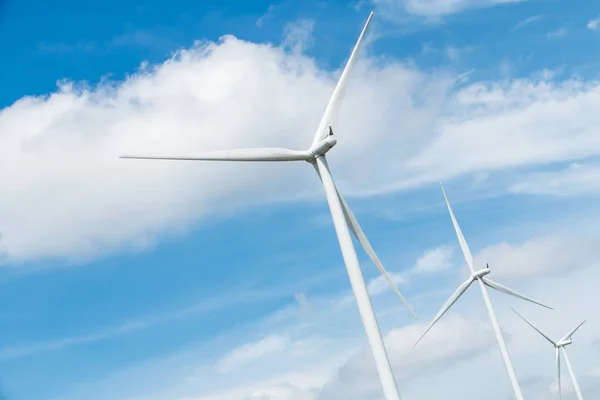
[415,183,552,400]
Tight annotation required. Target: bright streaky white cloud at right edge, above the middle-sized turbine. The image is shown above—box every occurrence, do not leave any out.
[386,79,600,195]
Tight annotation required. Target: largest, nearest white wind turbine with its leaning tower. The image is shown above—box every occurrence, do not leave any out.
[121,12,416,400]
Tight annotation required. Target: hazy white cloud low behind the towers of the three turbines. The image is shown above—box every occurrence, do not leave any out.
[50,228,600,400]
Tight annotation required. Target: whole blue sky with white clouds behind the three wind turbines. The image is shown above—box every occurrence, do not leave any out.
[0,0,600,400]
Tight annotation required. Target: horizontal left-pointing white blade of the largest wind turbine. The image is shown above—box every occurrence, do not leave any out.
[120,147,308,161]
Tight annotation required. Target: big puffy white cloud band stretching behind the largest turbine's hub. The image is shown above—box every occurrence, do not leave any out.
[0,20,600,268]
